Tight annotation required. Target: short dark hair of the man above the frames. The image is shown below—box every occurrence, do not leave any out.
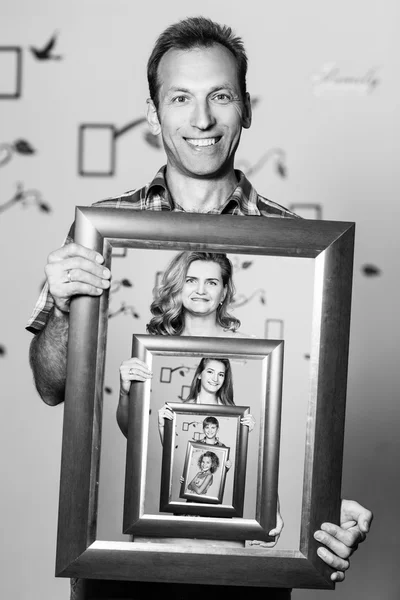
[147,17,247,109]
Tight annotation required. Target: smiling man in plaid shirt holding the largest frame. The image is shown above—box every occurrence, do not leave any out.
[28,17,372,598]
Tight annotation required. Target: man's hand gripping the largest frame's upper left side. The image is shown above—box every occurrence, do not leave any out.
[45,243,111,313]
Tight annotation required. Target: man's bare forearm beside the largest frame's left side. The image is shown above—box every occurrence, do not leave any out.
[29,309,69,406]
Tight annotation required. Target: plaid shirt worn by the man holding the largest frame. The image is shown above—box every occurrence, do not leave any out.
[26,166,299,333]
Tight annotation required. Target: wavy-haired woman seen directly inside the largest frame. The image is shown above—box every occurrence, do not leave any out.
[117,252,240,436]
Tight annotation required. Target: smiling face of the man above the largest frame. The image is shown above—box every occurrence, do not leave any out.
[148,44,250,179]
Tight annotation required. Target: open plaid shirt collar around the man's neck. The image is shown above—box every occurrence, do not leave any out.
[146,165,260,216]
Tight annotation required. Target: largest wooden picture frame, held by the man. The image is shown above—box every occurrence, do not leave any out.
[56,207,355,589]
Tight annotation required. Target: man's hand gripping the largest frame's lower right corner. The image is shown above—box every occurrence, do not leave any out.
[314,500,373,582]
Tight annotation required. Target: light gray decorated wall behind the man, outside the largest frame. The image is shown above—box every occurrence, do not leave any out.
[0,0,400,600]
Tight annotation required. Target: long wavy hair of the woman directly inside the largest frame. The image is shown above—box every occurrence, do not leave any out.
[146,252,240,335]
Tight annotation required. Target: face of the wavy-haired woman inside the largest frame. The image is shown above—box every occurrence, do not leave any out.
[182,260,226,316]
